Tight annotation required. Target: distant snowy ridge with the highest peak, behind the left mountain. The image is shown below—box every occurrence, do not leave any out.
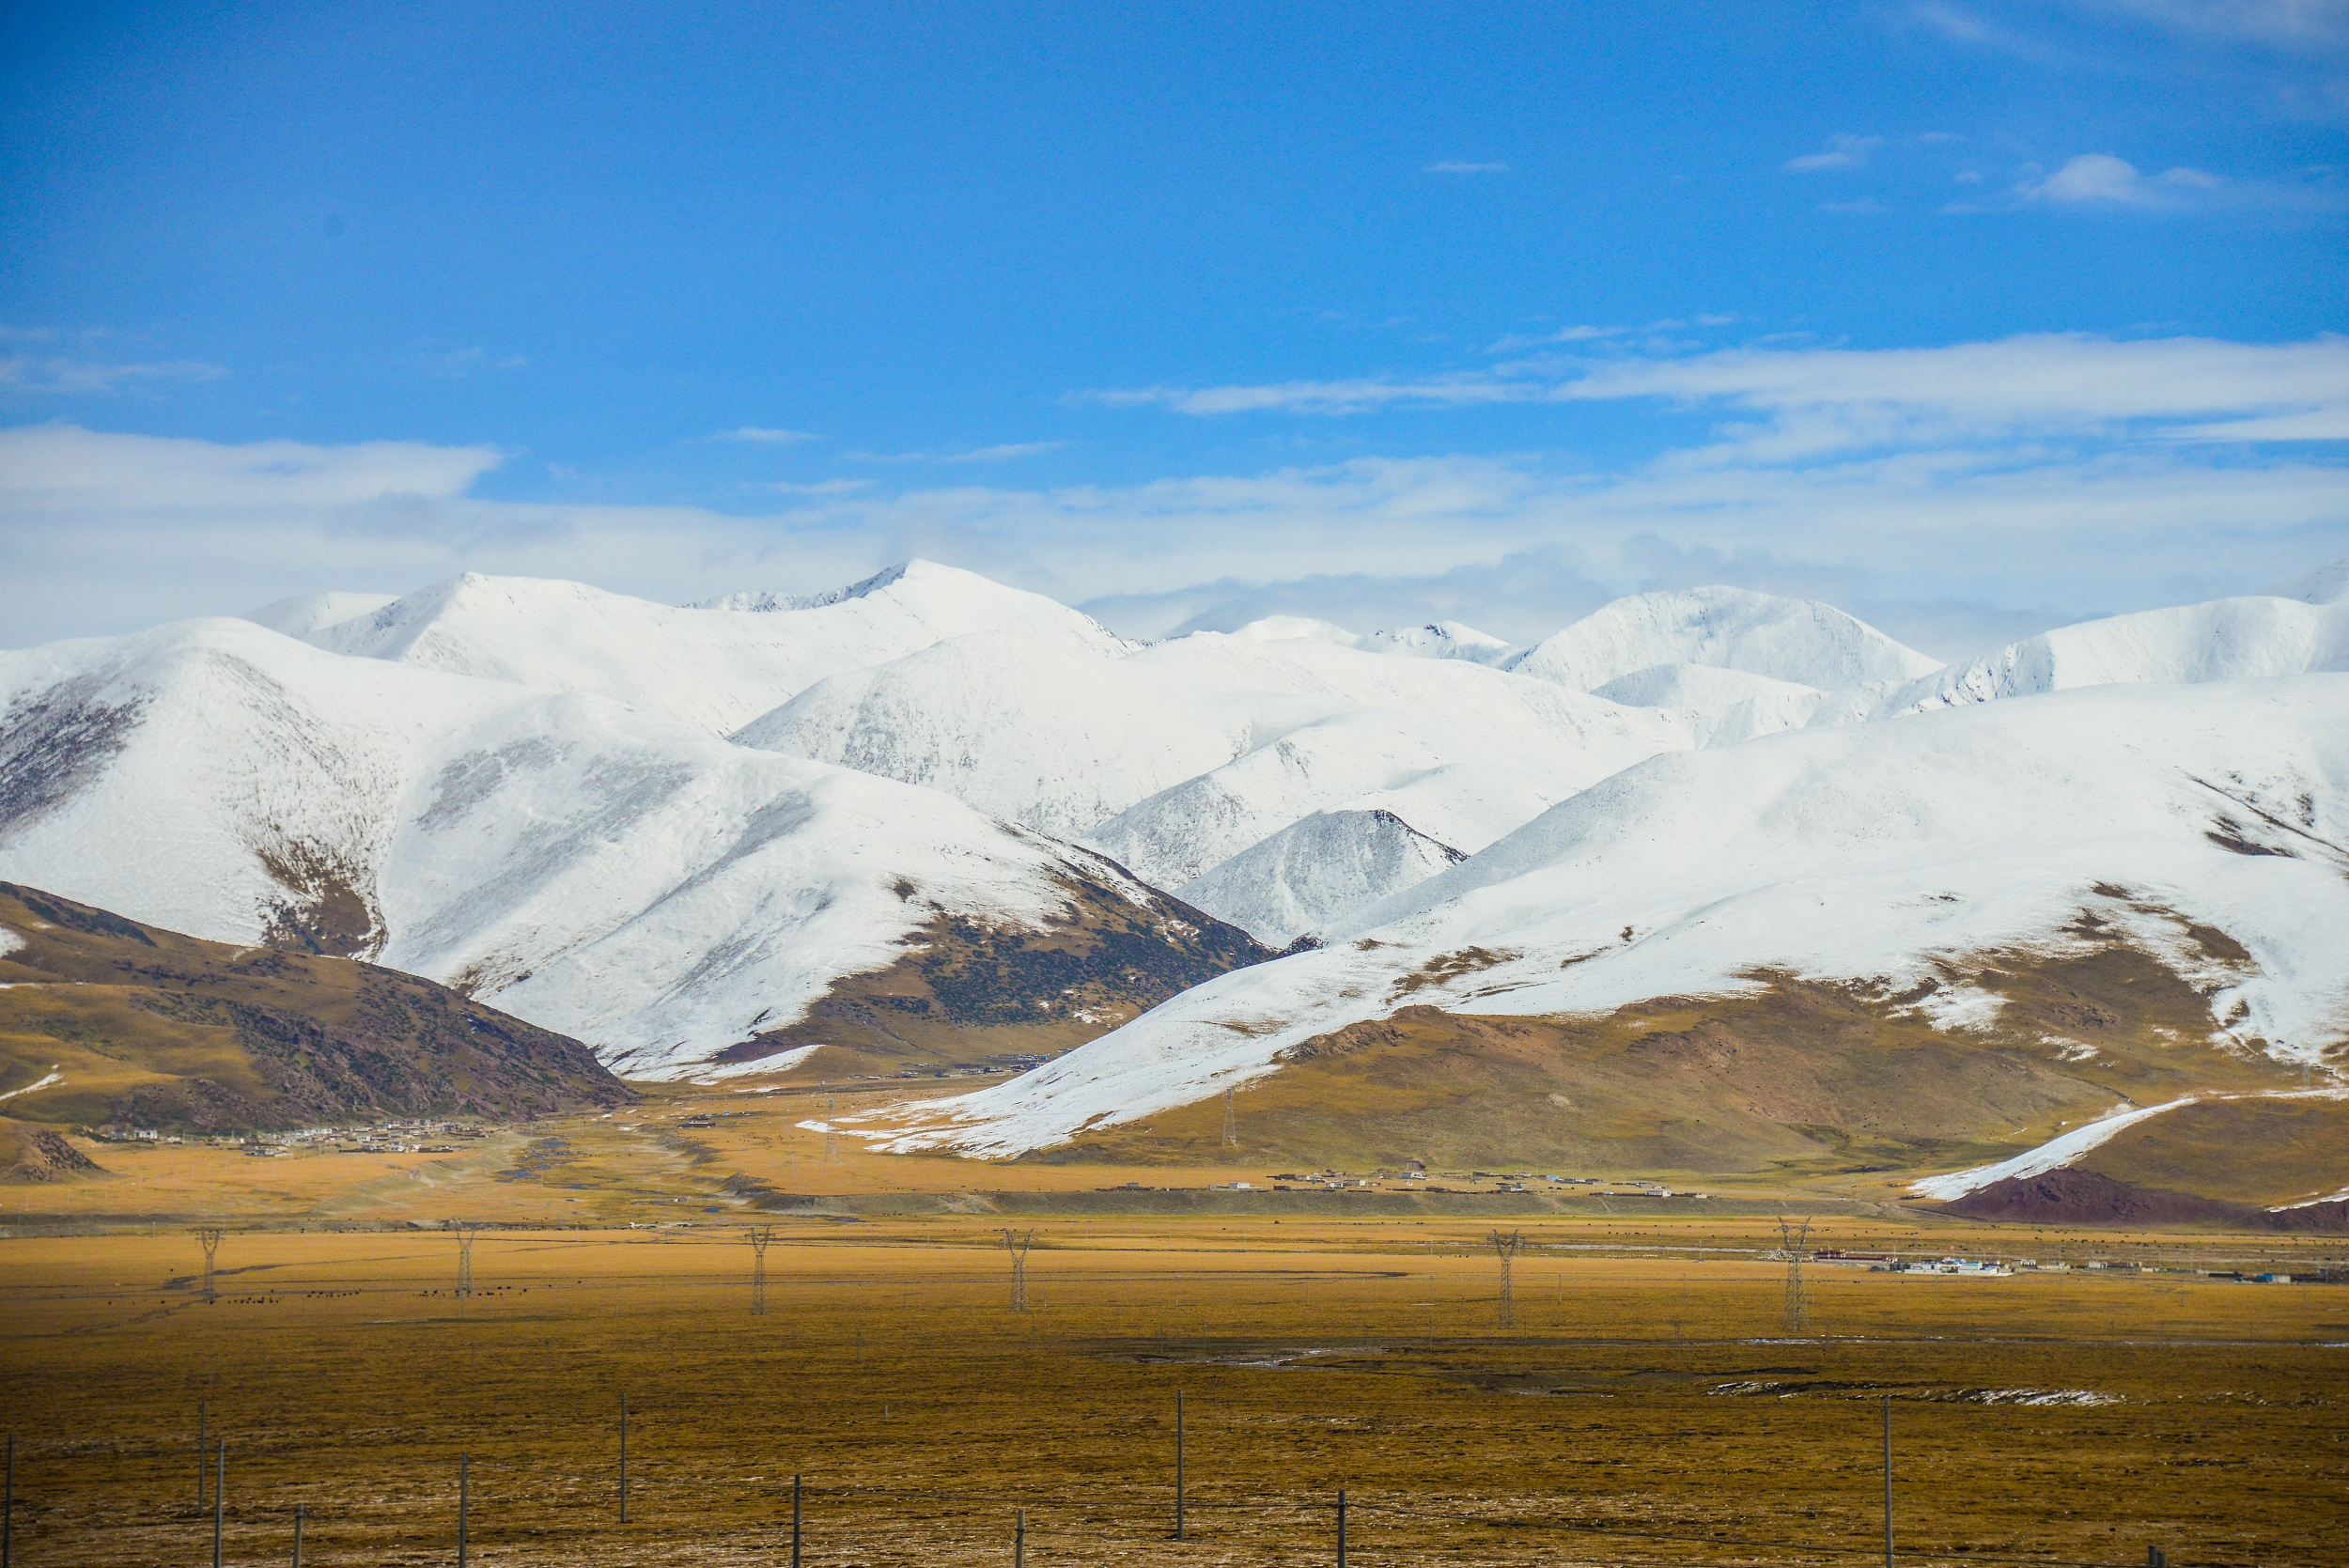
[274,561,1128,735]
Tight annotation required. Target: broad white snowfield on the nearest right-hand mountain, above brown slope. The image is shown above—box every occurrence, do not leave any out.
[872,674,2349,1153]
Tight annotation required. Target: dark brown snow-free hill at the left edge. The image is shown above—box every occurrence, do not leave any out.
[0,882,634,1129]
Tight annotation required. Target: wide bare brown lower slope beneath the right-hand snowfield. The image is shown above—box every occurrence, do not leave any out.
[1032,943,2297,1176]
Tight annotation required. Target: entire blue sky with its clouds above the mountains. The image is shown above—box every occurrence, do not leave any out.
[0,0,2349,653]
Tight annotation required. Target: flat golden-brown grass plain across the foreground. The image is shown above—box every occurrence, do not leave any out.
[0,1220,2349,1568]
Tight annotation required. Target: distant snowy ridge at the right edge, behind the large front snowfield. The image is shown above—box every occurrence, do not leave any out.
[1884,597,2349,714]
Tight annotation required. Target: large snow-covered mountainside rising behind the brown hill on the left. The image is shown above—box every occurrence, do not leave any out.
[0,620,1203,1075]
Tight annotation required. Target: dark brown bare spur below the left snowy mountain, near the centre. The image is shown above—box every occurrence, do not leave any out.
[719,876,1273,1078]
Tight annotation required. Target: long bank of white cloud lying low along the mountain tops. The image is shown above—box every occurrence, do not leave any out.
[0,335,2349,653]
